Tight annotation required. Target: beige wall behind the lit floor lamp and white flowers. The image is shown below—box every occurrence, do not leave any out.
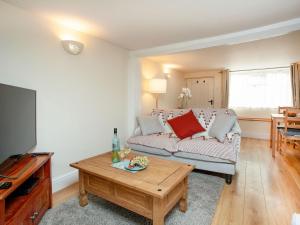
[141,59,185,114]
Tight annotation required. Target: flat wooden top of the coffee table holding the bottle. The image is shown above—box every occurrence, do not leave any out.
[70,152,194,198]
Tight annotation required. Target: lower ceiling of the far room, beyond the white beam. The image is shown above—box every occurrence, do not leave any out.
[148,31,300,73]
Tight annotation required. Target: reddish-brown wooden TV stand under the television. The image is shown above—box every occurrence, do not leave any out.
[0,153,53,225]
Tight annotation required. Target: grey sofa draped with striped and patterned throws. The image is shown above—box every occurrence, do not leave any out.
[127,109,241,184]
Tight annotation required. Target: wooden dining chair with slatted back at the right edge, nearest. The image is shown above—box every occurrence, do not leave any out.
[277,108,300,152]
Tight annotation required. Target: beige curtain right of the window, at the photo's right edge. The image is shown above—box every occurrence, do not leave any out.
[291,63,300,108]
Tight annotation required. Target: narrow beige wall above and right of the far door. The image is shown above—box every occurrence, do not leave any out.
[184,70,222,108]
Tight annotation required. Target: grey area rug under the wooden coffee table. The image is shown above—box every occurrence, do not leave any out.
[40,172,224,225]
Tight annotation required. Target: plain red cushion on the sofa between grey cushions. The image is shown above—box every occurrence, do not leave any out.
[168,110,205,139]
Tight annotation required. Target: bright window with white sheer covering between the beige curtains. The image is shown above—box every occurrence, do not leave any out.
[229,68,292,108]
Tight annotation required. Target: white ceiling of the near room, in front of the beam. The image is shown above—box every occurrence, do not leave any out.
[5,0,300,50]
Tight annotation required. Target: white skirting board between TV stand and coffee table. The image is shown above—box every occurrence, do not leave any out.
[52,170,78,193]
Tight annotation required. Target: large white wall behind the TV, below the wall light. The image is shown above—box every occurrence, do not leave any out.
[0,1,128,191]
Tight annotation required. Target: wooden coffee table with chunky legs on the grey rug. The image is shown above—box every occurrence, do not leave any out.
[70,152,194,225]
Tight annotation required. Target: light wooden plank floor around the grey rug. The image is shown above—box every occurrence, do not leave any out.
[53,138,300,225]
